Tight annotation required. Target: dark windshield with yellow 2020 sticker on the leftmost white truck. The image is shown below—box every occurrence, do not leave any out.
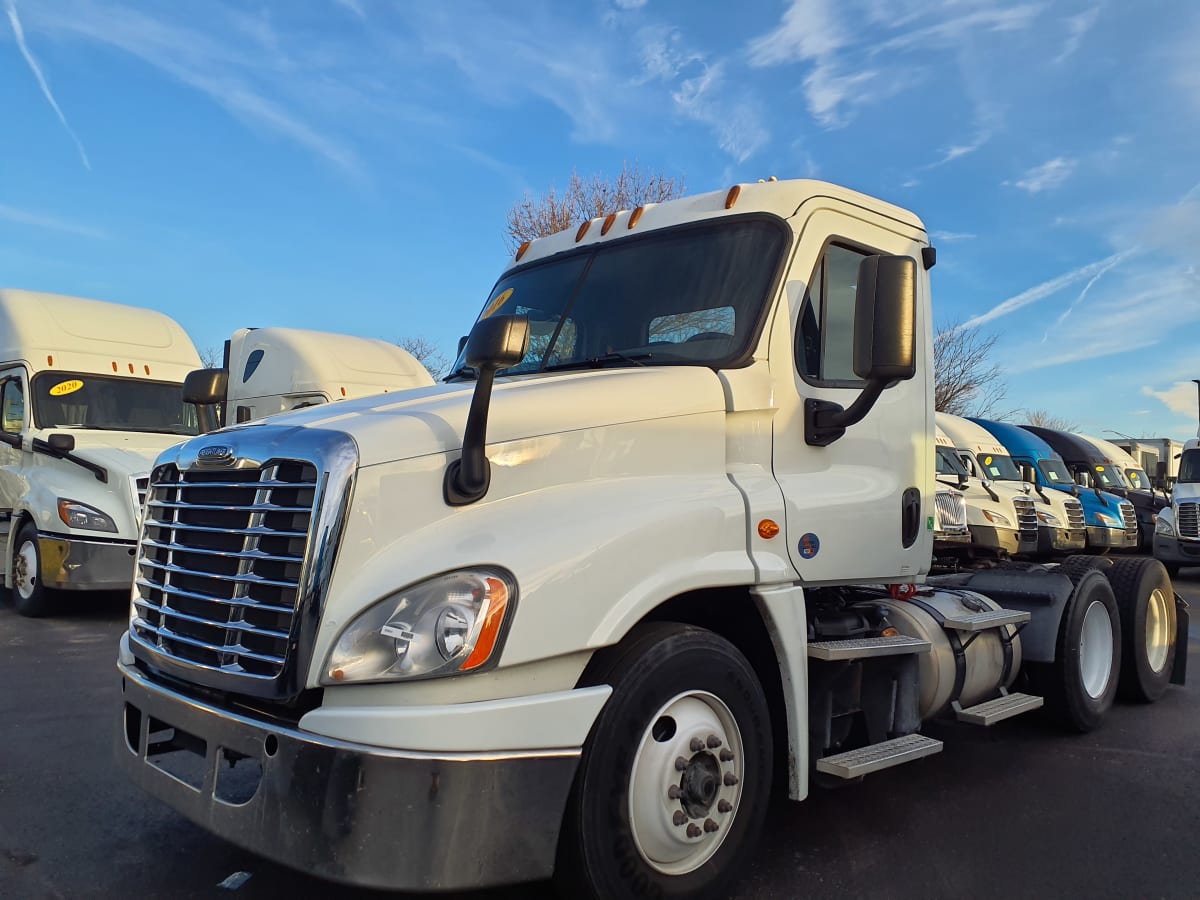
[31,372,199,434]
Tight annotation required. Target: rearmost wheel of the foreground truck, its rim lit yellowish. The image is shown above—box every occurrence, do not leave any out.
[1108,558,1175,703]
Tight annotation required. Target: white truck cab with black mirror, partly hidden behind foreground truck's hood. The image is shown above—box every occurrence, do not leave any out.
[185,328,433,431]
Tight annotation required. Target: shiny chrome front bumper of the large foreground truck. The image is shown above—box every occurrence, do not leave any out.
[116,665,580,890]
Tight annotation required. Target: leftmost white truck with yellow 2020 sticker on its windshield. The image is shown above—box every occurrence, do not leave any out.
[0,289,200,616]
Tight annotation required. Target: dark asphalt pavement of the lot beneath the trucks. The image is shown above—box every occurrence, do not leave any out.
[0,569,1200,900]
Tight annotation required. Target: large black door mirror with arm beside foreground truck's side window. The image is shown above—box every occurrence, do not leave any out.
[804,256,917,446]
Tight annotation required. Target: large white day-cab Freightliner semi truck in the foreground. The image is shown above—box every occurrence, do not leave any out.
[116,181,1187,900]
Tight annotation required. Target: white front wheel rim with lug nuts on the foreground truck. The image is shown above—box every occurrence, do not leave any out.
[629,691,745,875]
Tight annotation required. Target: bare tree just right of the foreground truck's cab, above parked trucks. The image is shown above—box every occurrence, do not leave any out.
[934,322,1010,419]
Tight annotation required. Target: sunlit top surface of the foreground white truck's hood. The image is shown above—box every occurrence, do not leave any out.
[211,366,726,466]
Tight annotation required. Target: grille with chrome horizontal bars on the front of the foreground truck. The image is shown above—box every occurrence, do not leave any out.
[130,461,318,679]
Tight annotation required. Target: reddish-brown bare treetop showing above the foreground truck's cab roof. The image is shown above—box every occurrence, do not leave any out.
[504,161,686,251]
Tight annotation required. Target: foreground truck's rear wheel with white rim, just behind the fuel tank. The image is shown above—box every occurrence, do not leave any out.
[1030,571,1121,733]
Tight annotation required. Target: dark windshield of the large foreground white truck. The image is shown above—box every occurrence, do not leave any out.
[452,216,786,374]
